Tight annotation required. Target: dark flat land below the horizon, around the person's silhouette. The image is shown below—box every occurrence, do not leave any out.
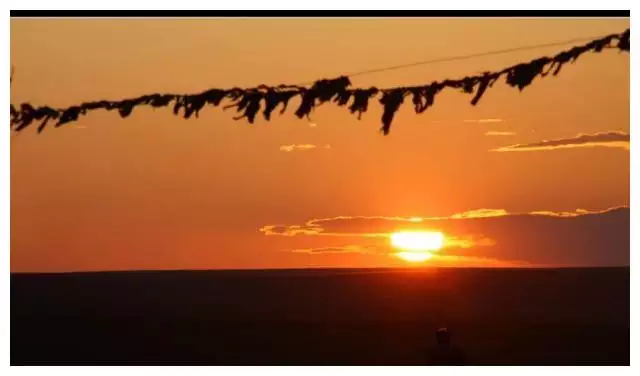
[11,268,629,365]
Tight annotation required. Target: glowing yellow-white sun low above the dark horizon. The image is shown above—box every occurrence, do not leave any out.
[390,231,444,262]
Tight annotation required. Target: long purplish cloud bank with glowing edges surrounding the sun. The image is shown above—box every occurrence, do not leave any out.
[260,206,630,266]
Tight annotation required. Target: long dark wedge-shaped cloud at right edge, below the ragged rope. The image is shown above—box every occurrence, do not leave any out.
[491,131,630,152]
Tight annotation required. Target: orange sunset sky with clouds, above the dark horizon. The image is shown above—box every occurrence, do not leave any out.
[10,18,630,272]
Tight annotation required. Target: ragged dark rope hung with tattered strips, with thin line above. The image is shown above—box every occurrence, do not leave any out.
[10,29,631,134]
